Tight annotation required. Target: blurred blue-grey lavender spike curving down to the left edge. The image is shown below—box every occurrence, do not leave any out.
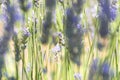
[0,1,15,54]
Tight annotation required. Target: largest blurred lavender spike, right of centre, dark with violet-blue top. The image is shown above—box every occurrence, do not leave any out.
[65,8,83,65]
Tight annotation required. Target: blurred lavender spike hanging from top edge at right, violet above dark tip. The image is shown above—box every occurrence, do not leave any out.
[99,0,110,38]
